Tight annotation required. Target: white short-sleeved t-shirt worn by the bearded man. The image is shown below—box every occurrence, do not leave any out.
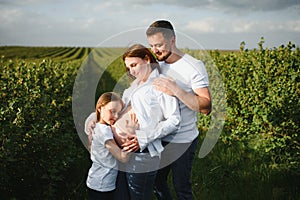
[159,54,209,143]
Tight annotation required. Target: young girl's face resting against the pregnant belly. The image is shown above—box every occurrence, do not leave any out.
[98,101,122,125]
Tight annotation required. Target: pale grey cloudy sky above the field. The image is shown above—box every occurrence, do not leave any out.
[0,0,300,49]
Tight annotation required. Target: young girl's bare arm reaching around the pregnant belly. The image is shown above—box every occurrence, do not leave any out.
[105,139,132,163]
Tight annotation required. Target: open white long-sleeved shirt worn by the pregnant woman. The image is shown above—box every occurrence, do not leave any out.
[122,69,181,156]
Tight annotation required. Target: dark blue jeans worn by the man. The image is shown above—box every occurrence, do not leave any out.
[155,138,198,200]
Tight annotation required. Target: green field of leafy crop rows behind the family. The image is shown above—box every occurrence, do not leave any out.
[0,41,300,200]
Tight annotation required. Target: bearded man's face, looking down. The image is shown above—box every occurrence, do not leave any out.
[147,33,172,61]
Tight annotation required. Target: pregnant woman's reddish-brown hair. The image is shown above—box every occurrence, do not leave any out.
[123,44,160,81]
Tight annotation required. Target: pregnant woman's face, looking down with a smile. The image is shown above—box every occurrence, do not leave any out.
[124,57,152,82]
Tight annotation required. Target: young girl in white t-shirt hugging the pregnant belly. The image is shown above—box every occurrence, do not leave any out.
[86,92,131,200]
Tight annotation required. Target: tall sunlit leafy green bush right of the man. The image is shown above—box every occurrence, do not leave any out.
[216,40,300,173]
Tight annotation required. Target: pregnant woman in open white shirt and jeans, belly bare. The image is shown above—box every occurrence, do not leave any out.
[86,44,180,200]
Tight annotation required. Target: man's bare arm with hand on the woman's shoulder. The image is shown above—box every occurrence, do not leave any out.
[153,77,212,115]
